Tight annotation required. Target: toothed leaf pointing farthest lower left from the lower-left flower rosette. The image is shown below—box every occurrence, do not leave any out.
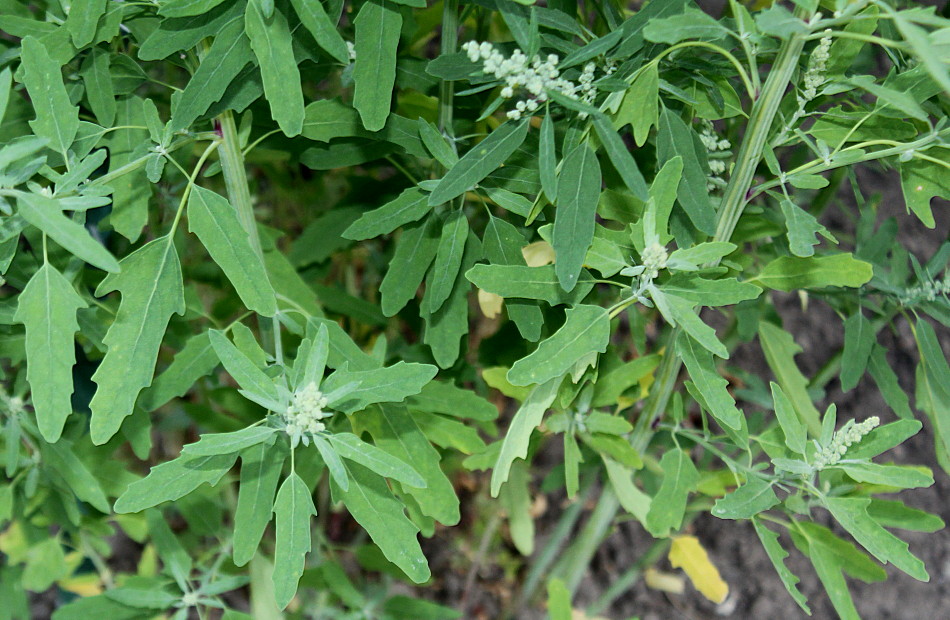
[114,454,237,514]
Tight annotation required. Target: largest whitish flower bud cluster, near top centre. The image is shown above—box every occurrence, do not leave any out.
[462,41,596,120]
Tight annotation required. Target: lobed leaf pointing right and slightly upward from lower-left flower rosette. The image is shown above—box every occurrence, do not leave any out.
[322,362,438,413]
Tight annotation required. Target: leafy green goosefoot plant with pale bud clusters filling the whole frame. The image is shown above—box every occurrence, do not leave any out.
[0,0,950,618]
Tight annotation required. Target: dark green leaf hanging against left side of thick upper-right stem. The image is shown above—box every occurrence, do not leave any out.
[657,108,718,235]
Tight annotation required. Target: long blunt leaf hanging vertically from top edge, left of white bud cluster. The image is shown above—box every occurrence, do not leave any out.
[353,0,404,131]
